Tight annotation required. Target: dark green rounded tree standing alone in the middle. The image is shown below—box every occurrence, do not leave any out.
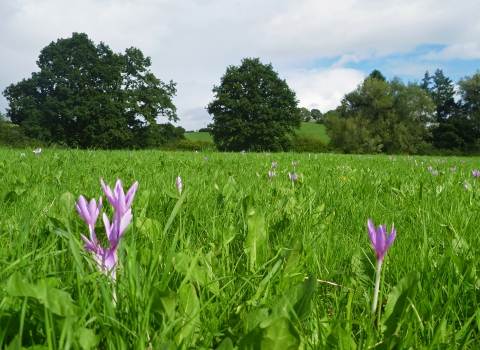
[207,58,301,151]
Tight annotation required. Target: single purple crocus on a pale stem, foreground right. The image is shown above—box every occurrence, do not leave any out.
[367,219,397,315]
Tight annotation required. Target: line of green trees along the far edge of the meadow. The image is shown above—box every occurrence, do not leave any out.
[0,33,480,154]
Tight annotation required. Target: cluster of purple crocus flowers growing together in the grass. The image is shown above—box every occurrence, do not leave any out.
[75,179,138,280]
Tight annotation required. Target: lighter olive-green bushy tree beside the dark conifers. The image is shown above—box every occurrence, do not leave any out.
[324,77,434,153]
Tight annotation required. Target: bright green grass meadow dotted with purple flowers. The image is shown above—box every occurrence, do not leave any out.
[0,149,480,350]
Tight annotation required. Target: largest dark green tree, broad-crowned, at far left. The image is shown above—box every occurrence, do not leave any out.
[3,33,178,149]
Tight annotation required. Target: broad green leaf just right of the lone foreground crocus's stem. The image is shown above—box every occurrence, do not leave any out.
[380,271,420,337]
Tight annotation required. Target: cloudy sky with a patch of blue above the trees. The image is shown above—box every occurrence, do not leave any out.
[0,0,480,130]
